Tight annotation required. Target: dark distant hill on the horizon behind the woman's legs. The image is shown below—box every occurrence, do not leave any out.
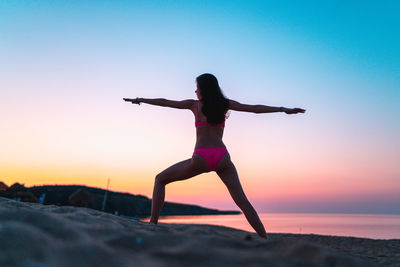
[7,185,241,218]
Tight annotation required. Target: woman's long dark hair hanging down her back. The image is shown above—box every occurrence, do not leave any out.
[196,73,229,124]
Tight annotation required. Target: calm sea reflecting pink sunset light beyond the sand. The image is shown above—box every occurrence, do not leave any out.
[144,213,400,239]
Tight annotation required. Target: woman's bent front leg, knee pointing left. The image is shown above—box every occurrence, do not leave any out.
[150,156,208,223]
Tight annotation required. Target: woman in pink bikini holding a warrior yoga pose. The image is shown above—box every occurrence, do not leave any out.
[124,73,305,238]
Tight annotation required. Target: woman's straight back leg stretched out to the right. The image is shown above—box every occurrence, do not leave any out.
[217,159,267,238]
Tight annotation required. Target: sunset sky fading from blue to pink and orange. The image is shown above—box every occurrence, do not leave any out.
[0,0,400,214]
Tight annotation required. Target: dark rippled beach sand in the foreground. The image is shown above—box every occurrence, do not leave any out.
[0,198,400,267]
